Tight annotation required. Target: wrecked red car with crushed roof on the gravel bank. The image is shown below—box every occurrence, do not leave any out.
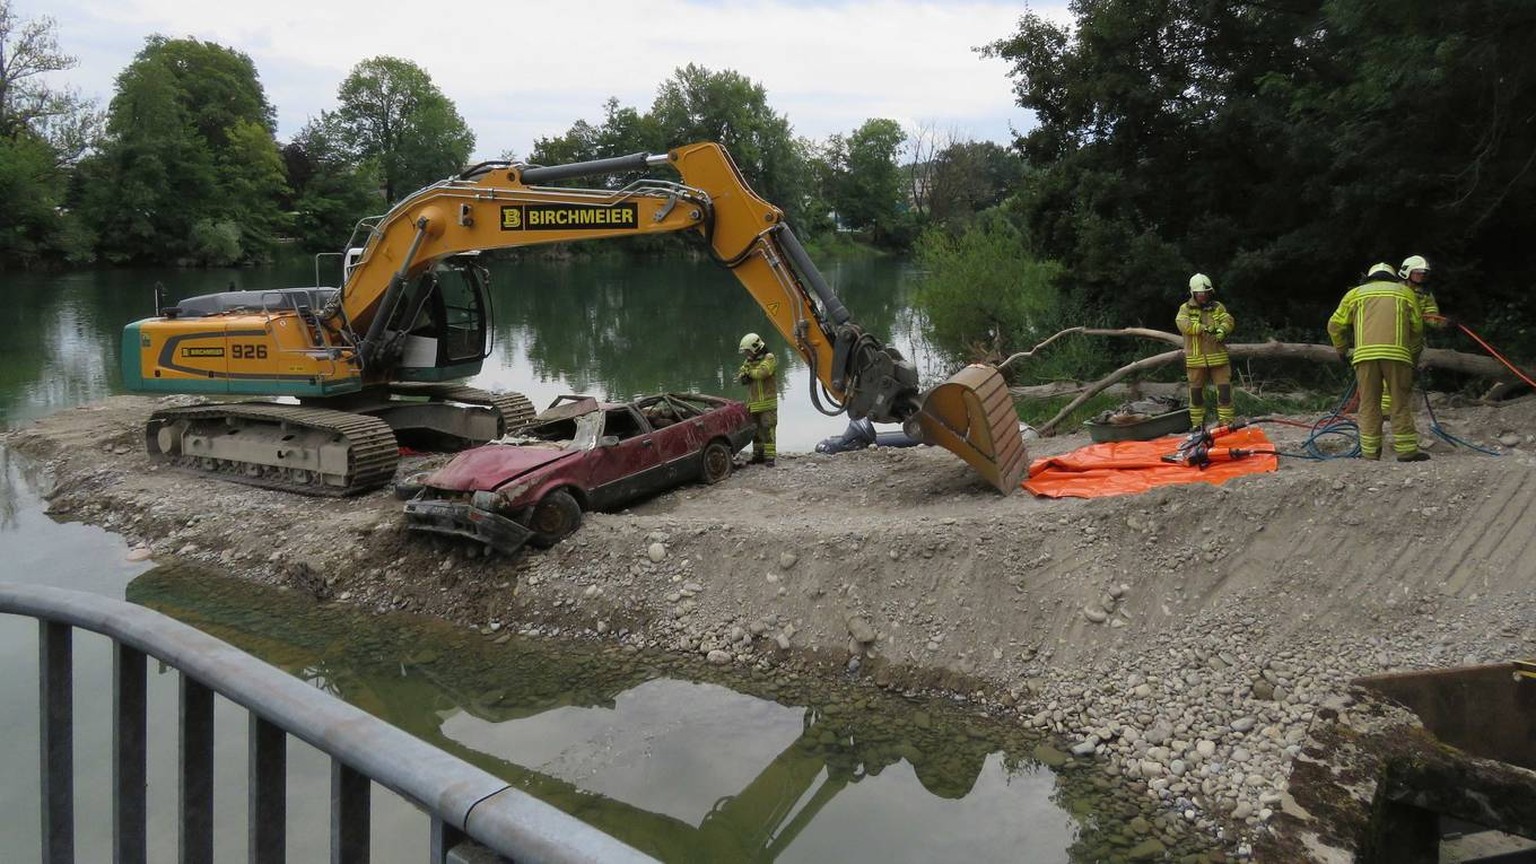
[406,394,753,553]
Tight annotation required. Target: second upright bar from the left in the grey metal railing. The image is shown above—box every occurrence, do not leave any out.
[112,643,149,864]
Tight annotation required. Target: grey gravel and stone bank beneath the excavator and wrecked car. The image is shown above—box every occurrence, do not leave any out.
[5,397,1536,859]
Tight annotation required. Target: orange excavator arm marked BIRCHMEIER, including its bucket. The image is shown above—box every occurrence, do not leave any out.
[337,143,1028,493]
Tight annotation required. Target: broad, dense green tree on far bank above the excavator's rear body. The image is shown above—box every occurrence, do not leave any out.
[81,35,284,264]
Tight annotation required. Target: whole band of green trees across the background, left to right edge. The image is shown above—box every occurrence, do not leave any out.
[0,0,1536,368]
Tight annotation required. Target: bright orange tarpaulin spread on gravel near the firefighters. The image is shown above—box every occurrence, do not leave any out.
[1023,426,1279,498]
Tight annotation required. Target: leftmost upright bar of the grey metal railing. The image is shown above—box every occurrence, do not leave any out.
[37,621,75,864]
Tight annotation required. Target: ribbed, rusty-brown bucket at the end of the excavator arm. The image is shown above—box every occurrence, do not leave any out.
[917,364,1029,495]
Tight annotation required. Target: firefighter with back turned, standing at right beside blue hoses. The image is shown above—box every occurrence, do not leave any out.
[1329,263,1430,463]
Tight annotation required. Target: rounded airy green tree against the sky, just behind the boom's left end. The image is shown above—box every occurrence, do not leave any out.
[330,57,475,204]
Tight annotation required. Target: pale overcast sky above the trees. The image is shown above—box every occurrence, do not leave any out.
[36,0,1064,158]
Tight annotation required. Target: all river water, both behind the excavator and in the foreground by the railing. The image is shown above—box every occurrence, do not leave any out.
[0,260,1114,862]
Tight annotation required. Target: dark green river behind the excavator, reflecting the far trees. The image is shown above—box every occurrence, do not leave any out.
[0,257,948,452]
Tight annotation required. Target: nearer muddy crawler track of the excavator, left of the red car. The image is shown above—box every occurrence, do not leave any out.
[144,403,399,498]
